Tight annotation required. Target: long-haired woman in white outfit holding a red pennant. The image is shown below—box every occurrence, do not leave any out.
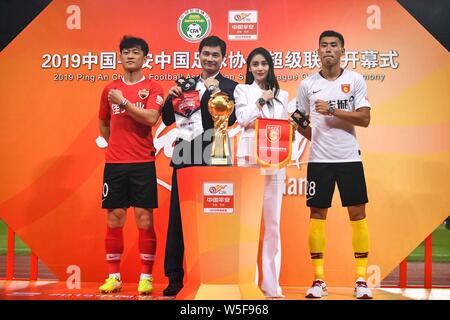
[234,47,294,298]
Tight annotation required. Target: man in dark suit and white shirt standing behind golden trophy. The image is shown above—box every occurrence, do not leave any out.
[162,36,237,296]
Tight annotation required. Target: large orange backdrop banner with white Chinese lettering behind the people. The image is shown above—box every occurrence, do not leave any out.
[0,0,450,285]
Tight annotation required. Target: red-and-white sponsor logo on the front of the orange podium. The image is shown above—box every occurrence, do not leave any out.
[203,182,234,214]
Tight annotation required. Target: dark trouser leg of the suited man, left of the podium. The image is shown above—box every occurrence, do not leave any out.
[164,168,184,282]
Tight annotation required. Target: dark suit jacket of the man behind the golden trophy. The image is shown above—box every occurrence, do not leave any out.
[162,73,237,169]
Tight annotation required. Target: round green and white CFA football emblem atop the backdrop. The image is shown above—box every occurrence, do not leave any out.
[177,8,211,42]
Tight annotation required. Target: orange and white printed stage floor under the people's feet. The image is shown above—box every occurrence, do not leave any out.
[0,280,450,301]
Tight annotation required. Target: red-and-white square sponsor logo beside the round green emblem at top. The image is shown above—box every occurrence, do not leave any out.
[228,10,258,40]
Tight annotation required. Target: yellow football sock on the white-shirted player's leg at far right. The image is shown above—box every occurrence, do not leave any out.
[350,218,369,279]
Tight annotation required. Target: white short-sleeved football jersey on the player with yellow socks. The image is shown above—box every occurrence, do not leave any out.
[297,70,371,162]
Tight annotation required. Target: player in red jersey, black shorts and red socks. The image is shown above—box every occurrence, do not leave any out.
[99,36,164,294]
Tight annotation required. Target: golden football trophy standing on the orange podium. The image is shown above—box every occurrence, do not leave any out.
[208,92,234,166]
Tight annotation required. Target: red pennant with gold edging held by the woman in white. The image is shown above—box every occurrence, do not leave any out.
[255,119,292,168]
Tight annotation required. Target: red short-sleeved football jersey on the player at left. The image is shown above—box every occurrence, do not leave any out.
[99,77,164,163]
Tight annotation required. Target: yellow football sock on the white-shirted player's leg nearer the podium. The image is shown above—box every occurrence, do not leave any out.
[309,219,326,280]
